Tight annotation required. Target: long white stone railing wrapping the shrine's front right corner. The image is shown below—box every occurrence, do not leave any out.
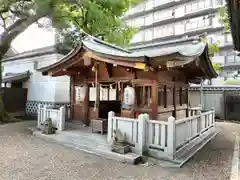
[108,109,215,160]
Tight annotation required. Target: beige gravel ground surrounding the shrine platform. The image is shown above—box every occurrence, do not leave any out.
[0,122,236,180]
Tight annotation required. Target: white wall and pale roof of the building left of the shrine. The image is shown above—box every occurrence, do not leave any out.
[3,54,70,103]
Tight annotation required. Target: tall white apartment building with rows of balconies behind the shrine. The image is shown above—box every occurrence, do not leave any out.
[123,0,240,84]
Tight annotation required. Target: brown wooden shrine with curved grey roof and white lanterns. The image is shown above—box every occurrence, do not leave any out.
[39,36,217,125]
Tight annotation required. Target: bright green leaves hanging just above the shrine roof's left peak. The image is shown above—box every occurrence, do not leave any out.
[53,0,142,52]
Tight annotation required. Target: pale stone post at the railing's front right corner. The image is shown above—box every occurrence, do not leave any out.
[167,116,176,159]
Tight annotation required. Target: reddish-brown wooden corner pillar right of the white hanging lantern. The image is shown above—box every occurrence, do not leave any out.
[152,81,158,120]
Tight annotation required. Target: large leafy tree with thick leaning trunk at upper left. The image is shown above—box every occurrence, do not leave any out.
[0,0,141,121]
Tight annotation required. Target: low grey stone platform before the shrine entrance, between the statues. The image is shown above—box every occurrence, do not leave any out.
[32,129,142,164]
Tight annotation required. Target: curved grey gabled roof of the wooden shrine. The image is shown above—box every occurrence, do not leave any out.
[38,36,217,78]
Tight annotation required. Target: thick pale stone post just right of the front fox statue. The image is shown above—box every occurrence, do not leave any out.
[138,114,149,155]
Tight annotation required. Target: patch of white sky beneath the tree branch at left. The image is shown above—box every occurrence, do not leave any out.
[0,24,55,53]
